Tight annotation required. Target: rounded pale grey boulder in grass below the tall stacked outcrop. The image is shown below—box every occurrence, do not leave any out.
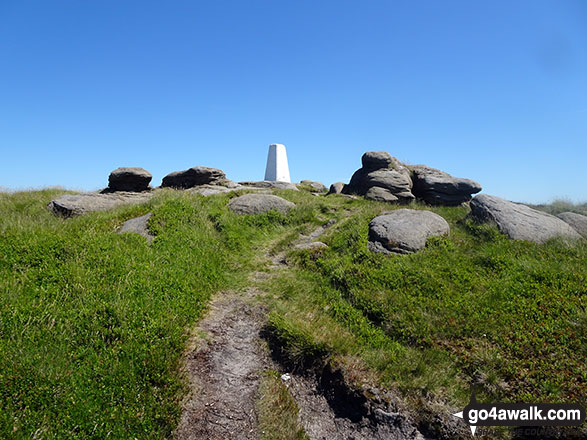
[368,209,450,254]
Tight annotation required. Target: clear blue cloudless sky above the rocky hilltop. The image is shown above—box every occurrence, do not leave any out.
[0,0,587,202]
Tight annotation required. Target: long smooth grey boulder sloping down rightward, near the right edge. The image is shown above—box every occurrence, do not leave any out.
[471,194,581,243]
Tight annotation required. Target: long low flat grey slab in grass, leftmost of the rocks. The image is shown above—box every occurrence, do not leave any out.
[47,191,153,217]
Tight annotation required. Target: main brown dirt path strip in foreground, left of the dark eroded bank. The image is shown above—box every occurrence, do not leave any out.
[175,289,270,440]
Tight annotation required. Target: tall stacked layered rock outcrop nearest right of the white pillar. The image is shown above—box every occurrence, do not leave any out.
[342,151,414,202]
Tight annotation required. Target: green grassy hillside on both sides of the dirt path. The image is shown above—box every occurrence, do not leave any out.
[0,191,587,438]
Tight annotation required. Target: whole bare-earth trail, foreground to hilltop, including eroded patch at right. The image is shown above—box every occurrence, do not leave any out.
[175,223,424,440]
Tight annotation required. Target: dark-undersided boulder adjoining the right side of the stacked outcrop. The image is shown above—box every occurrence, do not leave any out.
[410,165,481,206]
